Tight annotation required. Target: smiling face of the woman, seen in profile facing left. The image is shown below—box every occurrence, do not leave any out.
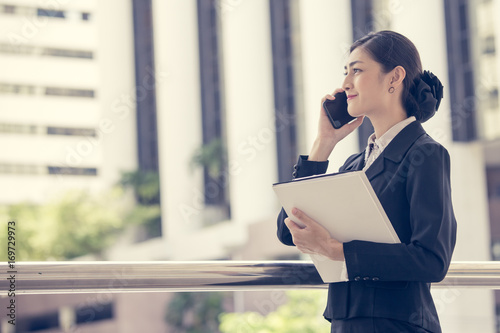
[342,47,390,117]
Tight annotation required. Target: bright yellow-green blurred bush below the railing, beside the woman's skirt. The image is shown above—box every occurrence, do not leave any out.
[219,290,330,333]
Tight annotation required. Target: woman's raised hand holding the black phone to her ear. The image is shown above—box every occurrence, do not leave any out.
[308,88,364,161]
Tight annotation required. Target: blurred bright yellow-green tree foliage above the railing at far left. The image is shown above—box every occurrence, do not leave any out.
[0,192,123,260]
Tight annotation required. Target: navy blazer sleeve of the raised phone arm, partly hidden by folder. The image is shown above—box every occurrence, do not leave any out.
[277,155,328,246]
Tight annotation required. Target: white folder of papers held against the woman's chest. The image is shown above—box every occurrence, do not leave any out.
[273,171,399,283]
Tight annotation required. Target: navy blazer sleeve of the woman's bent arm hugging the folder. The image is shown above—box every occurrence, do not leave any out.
[343,143,456,282]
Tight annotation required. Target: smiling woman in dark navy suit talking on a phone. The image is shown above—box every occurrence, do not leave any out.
[278,31,456,333]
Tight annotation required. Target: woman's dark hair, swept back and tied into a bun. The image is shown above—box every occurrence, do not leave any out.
[350,30,442,122]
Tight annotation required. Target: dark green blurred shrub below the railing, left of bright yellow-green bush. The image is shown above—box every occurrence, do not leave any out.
[165,292,224,333]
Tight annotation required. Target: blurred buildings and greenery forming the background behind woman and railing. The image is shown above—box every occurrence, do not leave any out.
[0,0,500,333]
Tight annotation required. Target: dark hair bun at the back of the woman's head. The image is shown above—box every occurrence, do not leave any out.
[410,71,443,123]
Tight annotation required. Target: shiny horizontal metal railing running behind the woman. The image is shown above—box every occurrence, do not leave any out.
[0,261,500,295]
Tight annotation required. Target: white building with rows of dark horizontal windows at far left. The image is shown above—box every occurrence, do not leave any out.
[0,0,137,204]
